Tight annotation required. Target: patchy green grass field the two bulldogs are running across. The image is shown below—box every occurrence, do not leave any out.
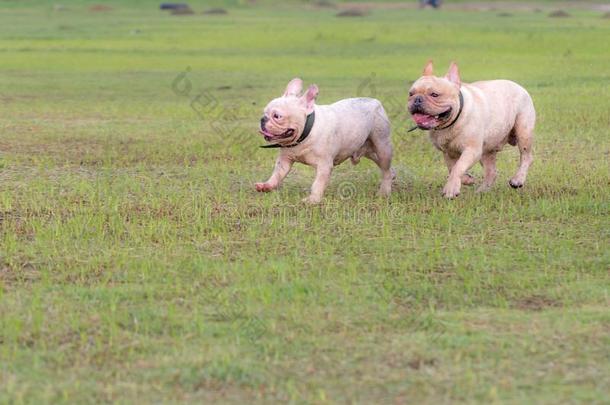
[0,0,610,404]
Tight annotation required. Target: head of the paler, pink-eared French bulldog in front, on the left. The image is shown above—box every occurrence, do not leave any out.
[259,78,318,145]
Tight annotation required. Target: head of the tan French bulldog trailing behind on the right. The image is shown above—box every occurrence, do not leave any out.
[408,61,462,129]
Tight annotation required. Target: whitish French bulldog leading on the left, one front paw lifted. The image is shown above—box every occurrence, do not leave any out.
[255,78,394,204]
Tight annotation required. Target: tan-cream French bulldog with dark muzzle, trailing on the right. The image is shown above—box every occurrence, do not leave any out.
[408,61,536,198]
